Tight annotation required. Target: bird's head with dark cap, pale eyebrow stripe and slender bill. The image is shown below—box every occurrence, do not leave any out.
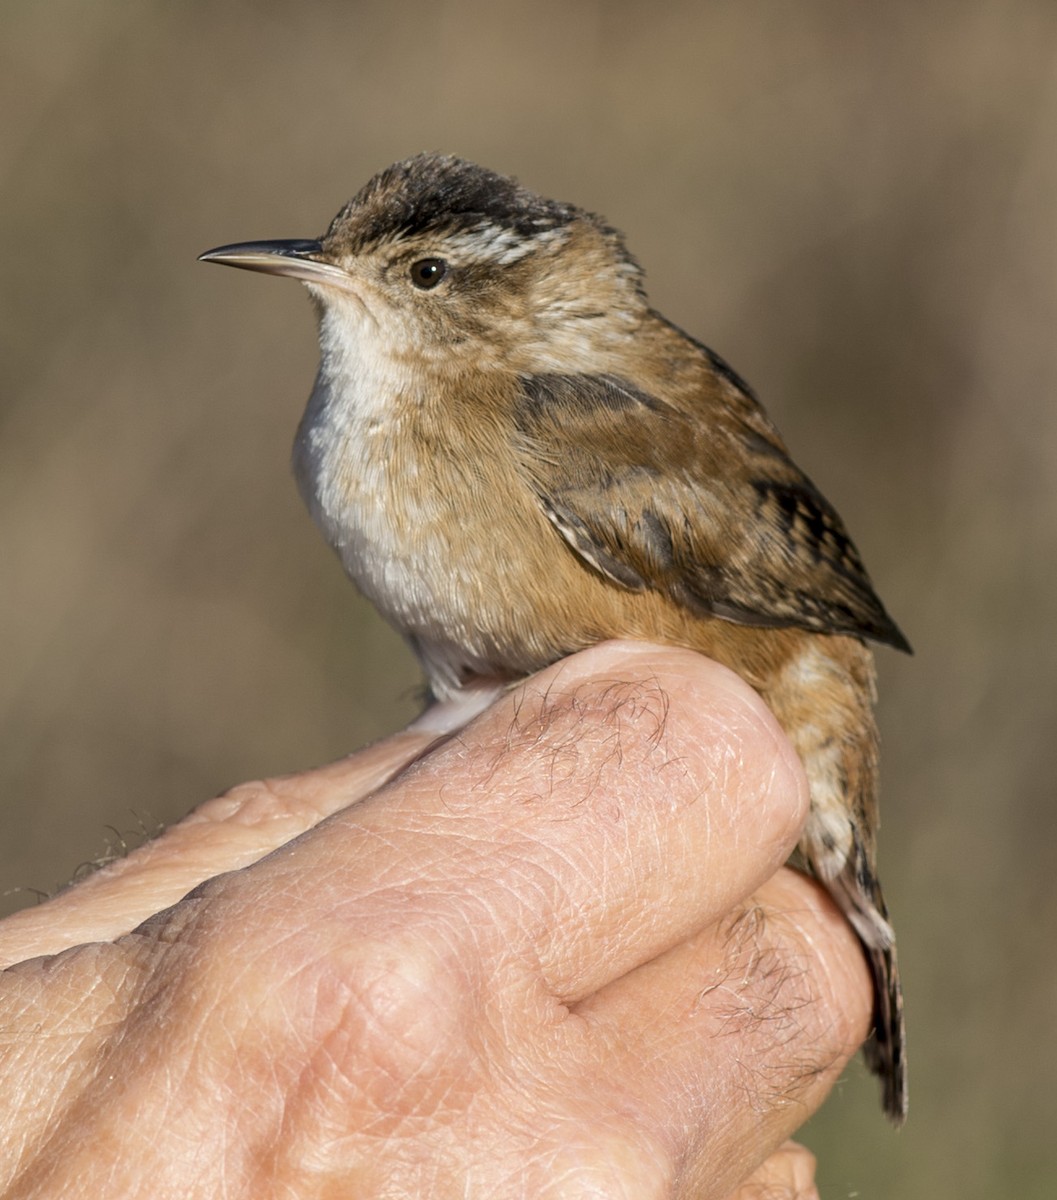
[202,154,648,372]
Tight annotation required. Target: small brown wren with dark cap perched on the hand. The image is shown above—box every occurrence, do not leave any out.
[200,154,909,1123]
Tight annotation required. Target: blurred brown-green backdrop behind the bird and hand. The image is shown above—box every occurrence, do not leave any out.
[0,0,1057,1200]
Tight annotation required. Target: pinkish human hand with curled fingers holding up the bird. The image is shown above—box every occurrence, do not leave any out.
[0,643,870,1200]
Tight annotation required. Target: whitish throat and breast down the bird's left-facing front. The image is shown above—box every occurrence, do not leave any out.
[293,291,506,694]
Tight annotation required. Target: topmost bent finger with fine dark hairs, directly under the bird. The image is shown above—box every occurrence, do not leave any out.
[249,643,807,1003]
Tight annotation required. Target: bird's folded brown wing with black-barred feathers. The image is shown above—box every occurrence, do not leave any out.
[515,374,909,649]
